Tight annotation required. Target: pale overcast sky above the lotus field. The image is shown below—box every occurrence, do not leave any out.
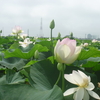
[0,0,100,37]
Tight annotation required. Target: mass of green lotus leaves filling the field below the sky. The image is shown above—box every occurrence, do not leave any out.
[0,26,100,100]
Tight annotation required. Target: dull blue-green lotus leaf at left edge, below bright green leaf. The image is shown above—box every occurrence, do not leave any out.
[0,55,25,69]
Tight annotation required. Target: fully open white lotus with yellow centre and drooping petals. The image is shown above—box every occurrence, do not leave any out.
[64,70,100,100]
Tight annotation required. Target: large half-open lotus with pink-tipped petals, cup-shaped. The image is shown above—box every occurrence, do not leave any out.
[54,38,82,64]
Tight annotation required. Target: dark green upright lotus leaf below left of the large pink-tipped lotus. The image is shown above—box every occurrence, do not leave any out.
[30,60,59,90]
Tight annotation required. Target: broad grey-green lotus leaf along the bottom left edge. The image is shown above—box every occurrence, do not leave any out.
[0,84,63,100]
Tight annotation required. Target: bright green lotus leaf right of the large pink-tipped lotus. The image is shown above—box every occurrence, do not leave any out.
[78,48,100,60]
